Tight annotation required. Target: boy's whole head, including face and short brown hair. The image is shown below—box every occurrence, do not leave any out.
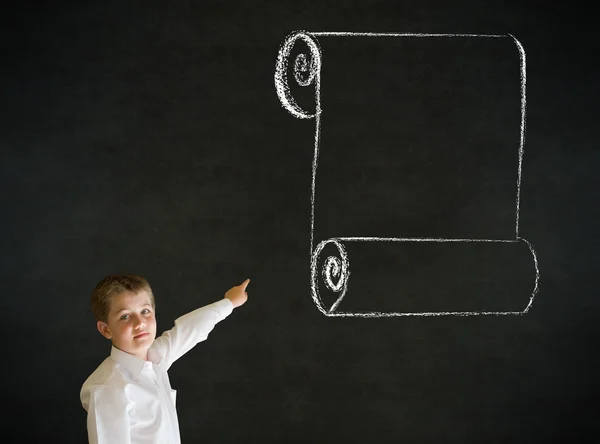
[91,275,156,359]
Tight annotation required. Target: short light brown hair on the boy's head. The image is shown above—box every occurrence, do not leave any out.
[91,274,155,322]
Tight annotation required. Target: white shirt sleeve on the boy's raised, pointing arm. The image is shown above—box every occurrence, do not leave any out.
[152,298,233,369]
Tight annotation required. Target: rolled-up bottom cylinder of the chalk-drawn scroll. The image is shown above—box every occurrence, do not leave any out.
[311,238,539,317]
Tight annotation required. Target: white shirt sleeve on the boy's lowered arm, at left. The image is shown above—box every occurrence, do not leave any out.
[82,385,132,444]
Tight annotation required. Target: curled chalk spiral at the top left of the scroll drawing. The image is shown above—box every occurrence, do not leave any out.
[275,31,321,119]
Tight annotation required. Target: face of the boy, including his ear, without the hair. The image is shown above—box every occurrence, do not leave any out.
[97,291,156,360]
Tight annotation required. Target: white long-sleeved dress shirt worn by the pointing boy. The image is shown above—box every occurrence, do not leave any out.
[80,299,233,444]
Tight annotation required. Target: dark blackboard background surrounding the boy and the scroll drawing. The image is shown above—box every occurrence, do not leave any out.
[0,1,600,443]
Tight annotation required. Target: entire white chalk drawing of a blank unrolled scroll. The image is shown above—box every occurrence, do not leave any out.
[274,31,540,318]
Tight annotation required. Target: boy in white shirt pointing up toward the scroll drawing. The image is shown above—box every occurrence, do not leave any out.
[80,275,250,444]
